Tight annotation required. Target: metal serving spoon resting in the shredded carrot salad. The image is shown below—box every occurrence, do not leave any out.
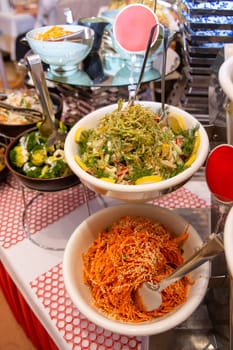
[138,233,224,311]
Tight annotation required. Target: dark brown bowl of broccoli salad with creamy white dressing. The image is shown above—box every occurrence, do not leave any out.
[5,128,80,192]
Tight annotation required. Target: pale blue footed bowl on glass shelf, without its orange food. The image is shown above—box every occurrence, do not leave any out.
[26,24,95,76]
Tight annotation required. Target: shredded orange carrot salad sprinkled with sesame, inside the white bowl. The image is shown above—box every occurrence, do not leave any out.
[83,216,191,322]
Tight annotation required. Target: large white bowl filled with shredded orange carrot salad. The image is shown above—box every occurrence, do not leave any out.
[63,204,210,336]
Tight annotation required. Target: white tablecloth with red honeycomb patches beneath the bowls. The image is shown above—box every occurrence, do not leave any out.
[0,175,210,350]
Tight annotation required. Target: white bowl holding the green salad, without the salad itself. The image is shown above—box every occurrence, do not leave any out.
[64,101,209,202]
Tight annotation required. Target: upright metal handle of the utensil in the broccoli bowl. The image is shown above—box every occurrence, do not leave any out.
[26,54,55,134]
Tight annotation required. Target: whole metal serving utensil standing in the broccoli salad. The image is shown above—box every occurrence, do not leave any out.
[26,54,65,146]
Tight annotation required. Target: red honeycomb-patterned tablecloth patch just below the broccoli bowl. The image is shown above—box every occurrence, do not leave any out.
[0,178,96,248]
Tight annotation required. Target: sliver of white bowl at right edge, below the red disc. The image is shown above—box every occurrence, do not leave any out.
[224,207,233,277]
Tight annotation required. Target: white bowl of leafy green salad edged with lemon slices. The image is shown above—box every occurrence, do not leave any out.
[64,100,209,203]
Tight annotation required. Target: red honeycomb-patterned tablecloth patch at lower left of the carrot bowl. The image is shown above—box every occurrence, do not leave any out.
[30,264,142,350]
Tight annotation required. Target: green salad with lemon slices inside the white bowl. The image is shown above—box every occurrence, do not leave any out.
[75,103,200,185]
